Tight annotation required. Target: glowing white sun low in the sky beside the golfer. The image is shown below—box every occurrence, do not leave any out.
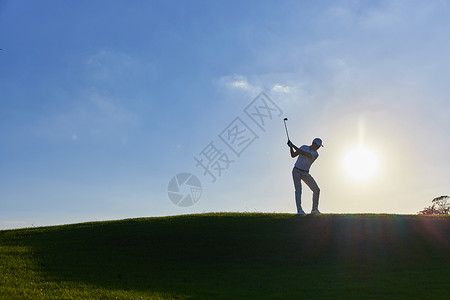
[343,145,378,180]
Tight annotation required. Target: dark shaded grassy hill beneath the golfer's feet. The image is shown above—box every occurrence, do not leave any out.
[0,213,450,299]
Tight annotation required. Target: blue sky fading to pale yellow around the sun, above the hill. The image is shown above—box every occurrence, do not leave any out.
[0,0,450,228]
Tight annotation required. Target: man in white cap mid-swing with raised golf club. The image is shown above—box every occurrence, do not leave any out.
[284,118,323,215]
